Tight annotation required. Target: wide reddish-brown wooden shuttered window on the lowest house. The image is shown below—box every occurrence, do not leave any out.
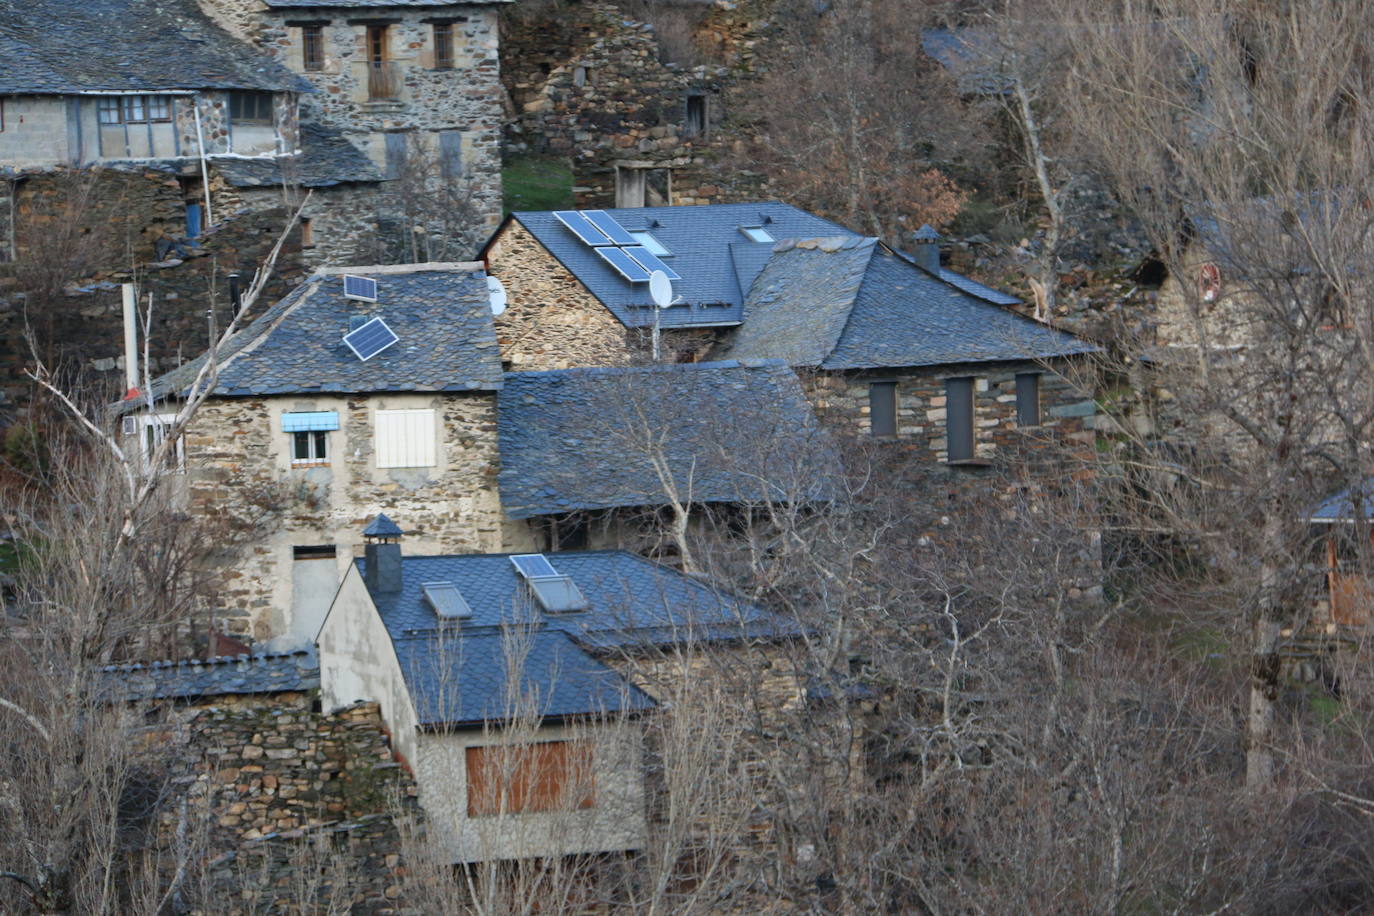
[464,742,596,817]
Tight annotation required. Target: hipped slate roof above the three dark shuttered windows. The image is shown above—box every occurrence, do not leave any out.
[725,238,1096,369]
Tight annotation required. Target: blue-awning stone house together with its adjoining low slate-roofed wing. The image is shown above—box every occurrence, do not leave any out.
[131,264,823,647]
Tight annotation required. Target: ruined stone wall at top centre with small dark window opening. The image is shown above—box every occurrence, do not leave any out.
[502,1,767,207]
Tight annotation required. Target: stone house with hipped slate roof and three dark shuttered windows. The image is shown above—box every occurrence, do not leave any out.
[723,227,1096,466]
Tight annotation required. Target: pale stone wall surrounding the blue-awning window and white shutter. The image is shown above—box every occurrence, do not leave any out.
[185,393,516,640]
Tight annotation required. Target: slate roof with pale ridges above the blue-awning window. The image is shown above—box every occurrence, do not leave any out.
[153,264,502,398]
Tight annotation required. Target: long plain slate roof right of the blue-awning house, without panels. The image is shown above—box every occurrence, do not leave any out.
[497,360,838,519]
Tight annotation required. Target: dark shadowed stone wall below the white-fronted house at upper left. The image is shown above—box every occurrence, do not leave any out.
[0,169,305,417]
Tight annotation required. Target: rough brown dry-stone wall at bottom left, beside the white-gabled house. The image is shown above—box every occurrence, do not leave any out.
[159,694,418,913]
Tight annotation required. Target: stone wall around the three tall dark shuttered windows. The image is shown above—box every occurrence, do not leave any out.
[802,363,1096,463]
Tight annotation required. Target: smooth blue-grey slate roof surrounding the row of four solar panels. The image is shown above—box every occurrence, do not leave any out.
[500,202,853,328]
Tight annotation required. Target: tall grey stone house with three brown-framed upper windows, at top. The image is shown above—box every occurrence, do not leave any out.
[202,0,508,243]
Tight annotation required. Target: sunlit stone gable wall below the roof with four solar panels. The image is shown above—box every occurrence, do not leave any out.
[486,220,629,372]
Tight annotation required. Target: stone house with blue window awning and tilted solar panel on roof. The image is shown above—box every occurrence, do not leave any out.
[136,264,508,644]
